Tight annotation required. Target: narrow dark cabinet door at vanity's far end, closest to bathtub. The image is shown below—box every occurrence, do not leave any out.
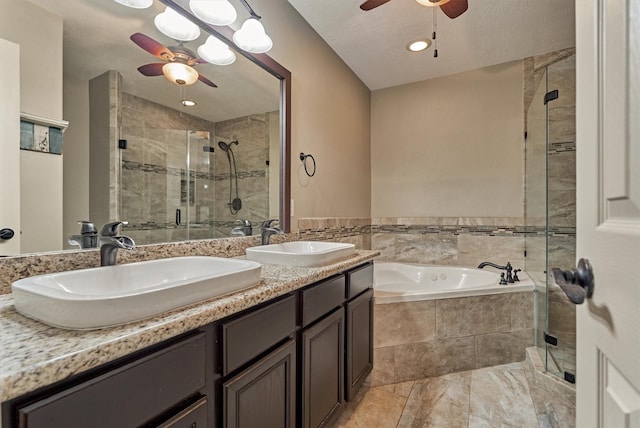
[346,289,373,401]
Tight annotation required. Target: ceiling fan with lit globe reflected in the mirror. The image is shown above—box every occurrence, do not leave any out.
[130,33,218,88]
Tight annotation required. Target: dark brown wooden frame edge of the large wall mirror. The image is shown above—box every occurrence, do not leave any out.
[160,0,291,233]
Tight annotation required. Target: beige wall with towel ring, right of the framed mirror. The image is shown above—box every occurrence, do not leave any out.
[251,0,371,229]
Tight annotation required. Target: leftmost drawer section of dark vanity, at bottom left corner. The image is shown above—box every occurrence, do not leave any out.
[3,332,213,428]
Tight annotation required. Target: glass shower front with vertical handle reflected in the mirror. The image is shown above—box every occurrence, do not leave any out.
[120,128,215,244]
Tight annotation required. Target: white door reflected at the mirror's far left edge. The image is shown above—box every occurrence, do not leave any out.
[0,39,20,256]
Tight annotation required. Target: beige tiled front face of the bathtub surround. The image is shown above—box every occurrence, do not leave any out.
[371,291,534,386]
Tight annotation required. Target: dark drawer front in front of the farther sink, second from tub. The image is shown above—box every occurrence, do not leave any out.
[301,275,345,327]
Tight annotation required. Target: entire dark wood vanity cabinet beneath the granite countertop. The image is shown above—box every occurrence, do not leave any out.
[2,263,373,428]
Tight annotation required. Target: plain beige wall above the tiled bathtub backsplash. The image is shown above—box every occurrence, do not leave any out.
[371,61,524,217]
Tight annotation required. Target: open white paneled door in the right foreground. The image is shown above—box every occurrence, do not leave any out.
[576,0,640,428]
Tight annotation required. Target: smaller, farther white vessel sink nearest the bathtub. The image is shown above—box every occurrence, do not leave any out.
[246,241,356,267]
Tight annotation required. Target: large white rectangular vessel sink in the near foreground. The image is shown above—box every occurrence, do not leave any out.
[11,257,261,330]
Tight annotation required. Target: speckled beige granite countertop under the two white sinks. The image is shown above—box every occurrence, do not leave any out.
[0,250,379,402]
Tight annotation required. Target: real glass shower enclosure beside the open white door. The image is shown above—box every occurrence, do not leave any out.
[525,49,576,383]
